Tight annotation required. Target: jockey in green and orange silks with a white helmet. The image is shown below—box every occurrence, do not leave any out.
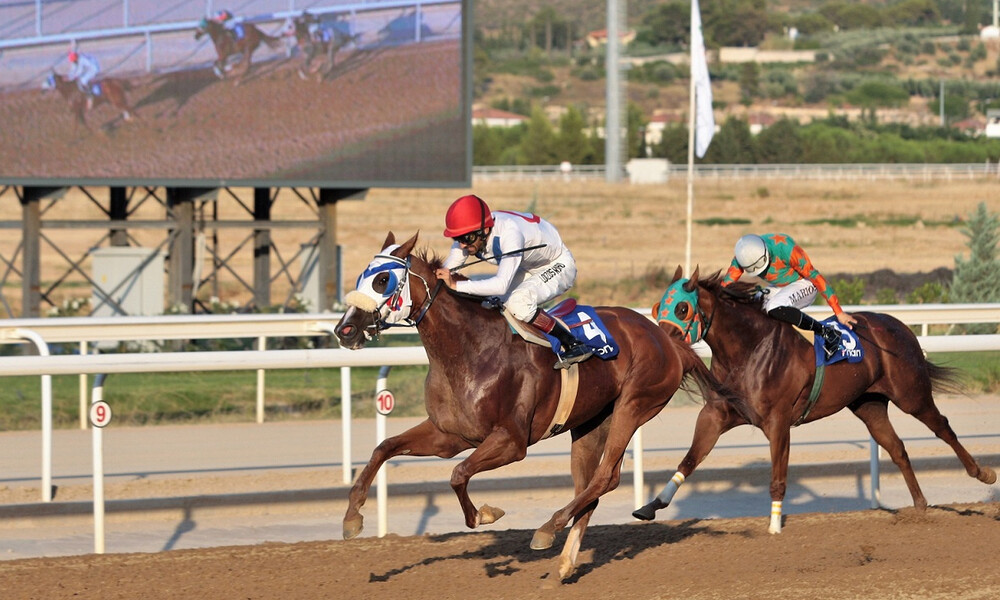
[722,233,857,357]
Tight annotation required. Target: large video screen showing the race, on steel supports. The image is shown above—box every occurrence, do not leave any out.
[0,0,471,188]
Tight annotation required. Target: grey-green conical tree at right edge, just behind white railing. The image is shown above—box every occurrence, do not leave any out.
[949,202,1000,333]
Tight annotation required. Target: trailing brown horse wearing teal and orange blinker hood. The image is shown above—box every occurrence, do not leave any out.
[632,267,997,533]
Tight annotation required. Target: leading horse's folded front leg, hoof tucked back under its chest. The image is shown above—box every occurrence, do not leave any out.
[451,427,528,529]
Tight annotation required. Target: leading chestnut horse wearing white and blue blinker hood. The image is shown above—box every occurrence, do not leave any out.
[336,232,744,578]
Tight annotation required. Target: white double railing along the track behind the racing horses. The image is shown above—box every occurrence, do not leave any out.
[0,304,1000,552]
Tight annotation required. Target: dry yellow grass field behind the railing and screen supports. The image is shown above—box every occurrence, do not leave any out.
[0,179,1000,312]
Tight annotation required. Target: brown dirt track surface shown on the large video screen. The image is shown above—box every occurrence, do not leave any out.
[0,41,466,183]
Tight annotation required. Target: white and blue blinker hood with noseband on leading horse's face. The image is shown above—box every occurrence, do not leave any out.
[345,245,413,324]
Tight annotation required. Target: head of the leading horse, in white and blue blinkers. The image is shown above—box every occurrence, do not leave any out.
[336,231,429,349]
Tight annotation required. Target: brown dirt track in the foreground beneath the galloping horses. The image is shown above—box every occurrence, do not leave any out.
[0,504,1000,600]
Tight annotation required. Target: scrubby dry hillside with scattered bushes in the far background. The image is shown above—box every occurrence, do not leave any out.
[474,0,1000,128]
